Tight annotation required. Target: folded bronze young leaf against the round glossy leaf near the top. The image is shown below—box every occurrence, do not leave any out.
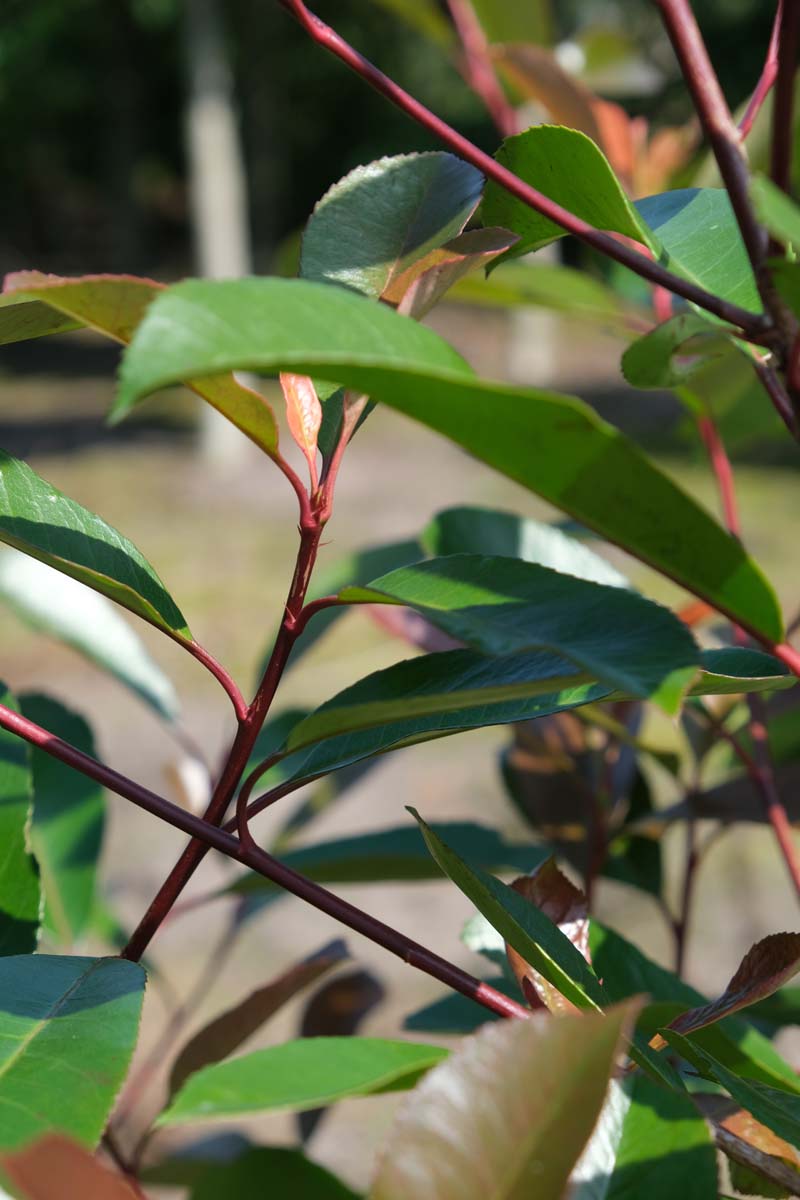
[381,229,519,320]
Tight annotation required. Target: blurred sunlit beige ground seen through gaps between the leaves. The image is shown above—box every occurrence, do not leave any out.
[0,302,800,1183]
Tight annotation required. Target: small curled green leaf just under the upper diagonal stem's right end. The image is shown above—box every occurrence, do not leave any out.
[622,312,733,388]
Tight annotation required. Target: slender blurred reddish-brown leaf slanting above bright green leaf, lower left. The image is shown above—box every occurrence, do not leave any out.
[169,941,347,1097]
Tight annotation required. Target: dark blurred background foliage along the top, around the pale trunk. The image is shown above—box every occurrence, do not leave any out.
[0,0,772,277]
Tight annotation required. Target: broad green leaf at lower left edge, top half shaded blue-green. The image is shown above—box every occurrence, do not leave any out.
[0,954,145,1150]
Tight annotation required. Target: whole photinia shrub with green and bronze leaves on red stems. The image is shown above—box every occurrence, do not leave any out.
[0,0,800,1200]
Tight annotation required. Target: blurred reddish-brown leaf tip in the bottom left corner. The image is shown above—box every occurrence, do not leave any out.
[0,1132,142,1200]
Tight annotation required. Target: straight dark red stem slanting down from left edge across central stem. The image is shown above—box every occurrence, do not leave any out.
[0,706,529,1016]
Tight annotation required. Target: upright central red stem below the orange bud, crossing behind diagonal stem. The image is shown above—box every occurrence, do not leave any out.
[122,520,323,962]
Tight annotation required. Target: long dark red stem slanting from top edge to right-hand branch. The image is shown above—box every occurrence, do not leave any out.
[278,0,772,342]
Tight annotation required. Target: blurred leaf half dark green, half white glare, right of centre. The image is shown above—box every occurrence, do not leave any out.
[422,506,628,588]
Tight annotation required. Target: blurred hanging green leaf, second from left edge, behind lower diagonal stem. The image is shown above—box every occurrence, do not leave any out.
[19,694,106,946]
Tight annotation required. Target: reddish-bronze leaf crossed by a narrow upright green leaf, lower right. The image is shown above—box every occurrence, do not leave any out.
[506,858,591,1013]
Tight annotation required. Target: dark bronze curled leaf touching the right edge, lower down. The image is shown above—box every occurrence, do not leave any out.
[669,934,800,1033]
